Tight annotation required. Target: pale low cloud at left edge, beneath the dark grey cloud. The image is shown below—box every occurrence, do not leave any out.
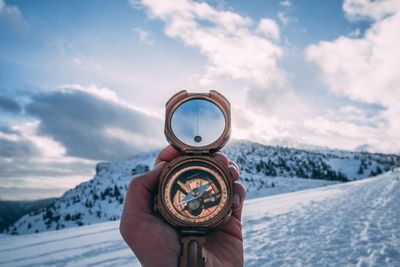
[0,155,96,199]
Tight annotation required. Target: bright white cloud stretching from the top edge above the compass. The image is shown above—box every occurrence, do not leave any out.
[132,0,283,87]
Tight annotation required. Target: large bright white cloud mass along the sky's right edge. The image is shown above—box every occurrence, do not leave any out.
[305,0,400,152]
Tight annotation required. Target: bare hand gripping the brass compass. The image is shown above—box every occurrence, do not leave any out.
[120,146,246,267]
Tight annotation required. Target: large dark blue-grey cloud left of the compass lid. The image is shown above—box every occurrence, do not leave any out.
[26,86,164,160]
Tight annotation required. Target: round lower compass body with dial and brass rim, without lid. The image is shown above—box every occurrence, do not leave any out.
[160,156,232,229]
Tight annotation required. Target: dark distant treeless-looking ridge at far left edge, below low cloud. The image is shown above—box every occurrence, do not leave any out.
[0,198,56,232]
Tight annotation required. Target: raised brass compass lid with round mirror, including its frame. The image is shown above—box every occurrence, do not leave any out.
[164,90,231,154]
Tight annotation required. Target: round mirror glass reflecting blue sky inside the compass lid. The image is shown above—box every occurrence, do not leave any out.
[171,99,225,147]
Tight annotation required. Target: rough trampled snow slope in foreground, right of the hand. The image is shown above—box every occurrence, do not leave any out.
[244,172,400,266]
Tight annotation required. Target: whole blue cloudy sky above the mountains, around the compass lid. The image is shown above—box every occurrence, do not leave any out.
[0,0,400,199]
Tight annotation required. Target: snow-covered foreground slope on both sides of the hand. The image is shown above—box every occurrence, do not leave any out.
[0,171,400,266]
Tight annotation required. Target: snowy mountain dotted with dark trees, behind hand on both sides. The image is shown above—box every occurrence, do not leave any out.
[5,141,400,234]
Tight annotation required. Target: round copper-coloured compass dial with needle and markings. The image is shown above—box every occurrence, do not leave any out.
[164,165,228,223]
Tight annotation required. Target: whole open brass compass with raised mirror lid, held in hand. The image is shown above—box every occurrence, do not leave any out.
[157,90,233,266]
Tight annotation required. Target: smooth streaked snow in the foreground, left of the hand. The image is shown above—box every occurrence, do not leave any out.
[0,222,140,266]
